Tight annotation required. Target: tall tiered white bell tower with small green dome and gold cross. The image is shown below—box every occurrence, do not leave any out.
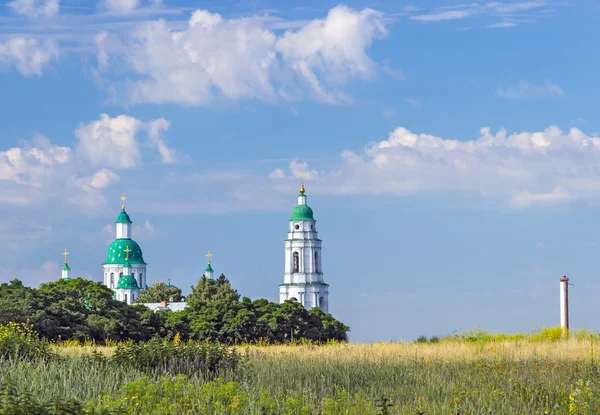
[279,182,329,313]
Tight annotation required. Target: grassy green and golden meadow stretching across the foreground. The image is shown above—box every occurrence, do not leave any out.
[0,329,600,415]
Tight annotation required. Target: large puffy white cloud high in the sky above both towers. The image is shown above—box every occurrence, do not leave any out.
[96,6,387,105]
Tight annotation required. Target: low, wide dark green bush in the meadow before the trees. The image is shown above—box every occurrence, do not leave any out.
[110,339,241,379]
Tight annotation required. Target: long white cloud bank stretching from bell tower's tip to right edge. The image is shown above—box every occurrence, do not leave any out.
[270,126,600,208]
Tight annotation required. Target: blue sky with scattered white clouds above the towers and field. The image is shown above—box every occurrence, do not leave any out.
[0,0,600,341]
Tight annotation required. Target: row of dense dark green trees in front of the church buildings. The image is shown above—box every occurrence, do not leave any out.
[0,274,349,344]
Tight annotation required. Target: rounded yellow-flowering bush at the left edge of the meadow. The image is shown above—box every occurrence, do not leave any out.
[0,323,52,360]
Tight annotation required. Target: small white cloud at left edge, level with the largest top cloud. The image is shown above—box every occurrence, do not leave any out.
[0,37,59,76]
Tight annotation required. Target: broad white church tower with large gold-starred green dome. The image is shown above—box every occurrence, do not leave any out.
[104,195,147,290]
